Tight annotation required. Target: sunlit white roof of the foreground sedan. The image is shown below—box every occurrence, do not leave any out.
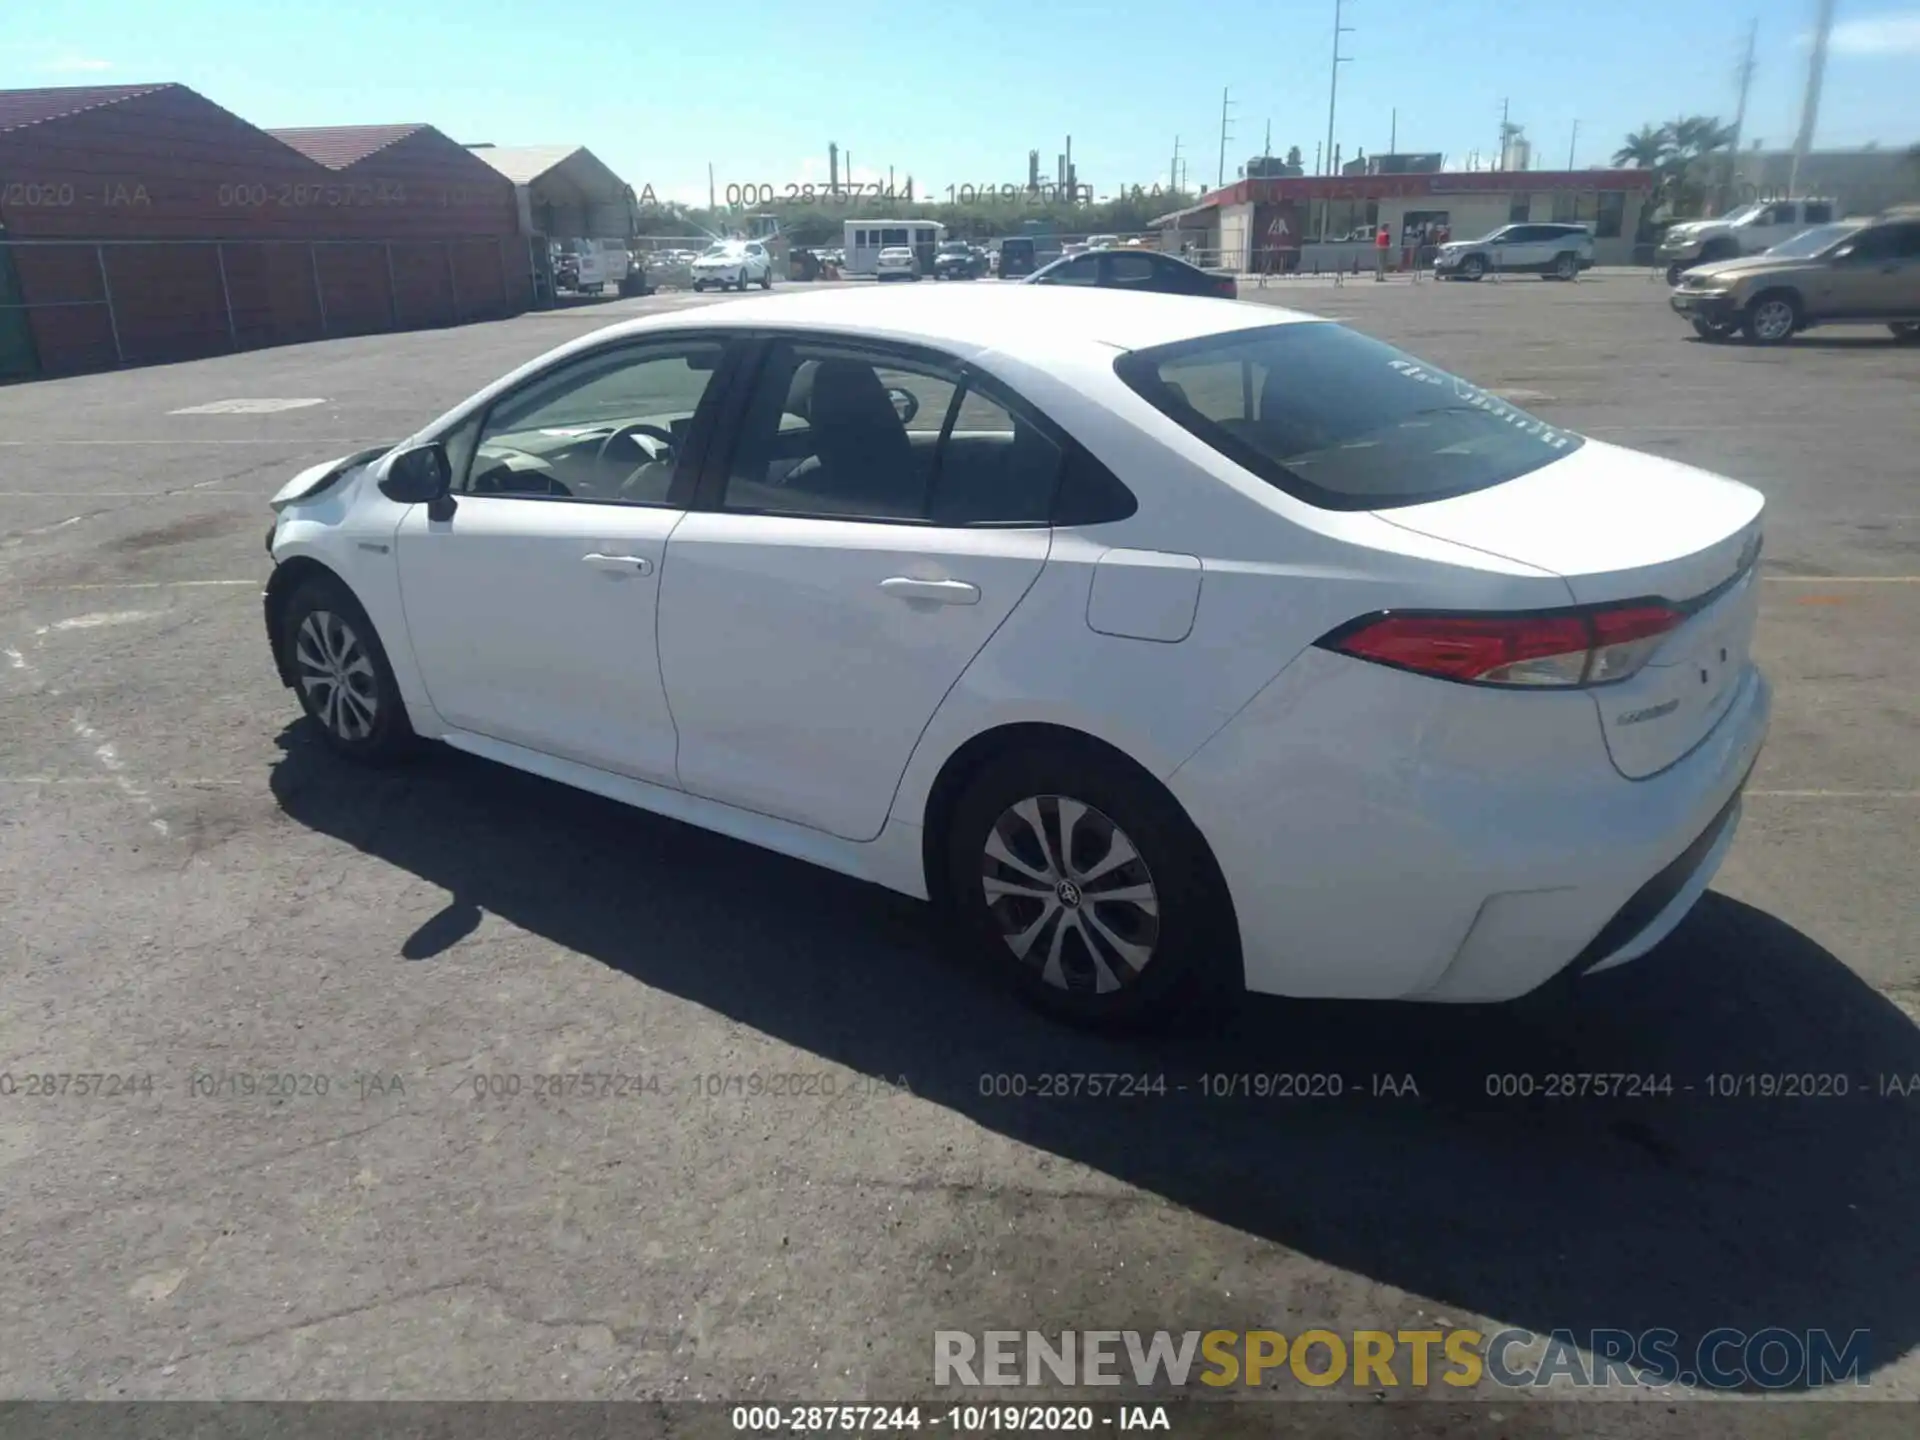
[595,284,1321,349]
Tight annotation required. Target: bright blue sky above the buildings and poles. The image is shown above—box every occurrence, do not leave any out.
[0,0,1920,200]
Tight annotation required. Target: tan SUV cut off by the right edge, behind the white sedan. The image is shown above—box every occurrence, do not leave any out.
[1672,213,1920,346]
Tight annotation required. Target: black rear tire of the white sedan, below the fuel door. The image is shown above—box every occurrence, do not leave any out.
[935,743,1240,1031]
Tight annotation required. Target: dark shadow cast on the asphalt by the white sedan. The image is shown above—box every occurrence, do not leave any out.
[271,722,1920,1397]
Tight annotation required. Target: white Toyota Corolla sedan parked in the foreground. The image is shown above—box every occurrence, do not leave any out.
[265,286,1770,1025]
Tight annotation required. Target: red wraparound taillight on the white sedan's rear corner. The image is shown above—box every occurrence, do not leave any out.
[1321,605,1686,687]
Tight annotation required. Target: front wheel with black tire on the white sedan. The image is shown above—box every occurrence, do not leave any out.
[280,576,417,764]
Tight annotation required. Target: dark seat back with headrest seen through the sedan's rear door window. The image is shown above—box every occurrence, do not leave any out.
[787,359,920,515]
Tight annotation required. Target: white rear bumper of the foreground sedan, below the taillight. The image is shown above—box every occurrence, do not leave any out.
[1169,651,1772,1002]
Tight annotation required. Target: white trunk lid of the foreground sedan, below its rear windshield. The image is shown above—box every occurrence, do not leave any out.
[1377,440,1766,780]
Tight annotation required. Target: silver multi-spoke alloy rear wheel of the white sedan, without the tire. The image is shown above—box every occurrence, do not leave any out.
[981,795,1160,995]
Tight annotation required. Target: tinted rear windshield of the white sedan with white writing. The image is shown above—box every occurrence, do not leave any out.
[1114,321,1584,511]
